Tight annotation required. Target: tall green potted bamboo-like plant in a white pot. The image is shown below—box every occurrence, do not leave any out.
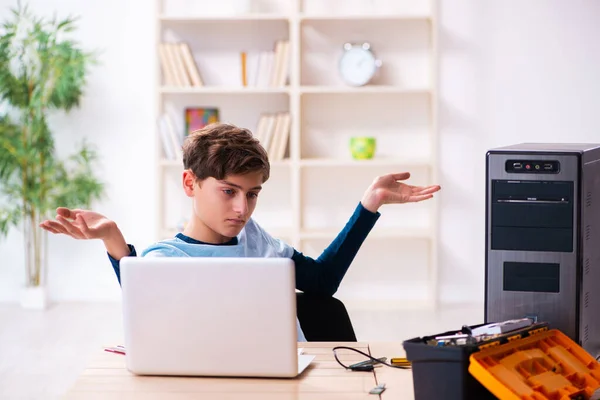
[0,4,103,308]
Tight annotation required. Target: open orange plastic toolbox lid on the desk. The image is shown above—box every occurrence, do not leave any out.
[469,329,600,400]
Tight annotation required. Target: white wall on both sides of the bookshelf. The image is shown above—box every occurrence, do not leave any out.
[0,0,600,302]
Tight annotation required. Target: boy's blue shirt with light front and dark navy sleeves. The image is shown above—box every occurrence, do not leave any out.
[109,203,380,296]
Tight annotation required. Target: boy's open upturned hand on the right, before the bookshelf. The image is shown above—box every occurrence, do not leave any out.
[361,172,440,212]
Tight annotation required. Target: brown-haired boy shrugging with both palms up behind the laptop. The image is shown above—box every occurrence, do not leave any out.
[41,124,440,341]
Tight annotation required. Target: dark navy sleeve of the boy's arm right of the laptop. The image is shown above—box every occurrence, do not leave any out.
[292,202,381,296]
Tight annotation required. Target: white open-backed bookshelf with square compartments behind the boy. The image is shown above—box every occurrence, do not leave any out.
[155,0,438,308]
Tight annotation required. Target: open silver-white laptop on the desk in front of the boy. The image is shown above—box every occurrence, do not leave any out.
[120,257,314,378]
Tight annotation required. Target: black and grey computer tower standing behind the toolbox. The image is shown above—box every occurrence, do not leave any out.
[485,143,600,357]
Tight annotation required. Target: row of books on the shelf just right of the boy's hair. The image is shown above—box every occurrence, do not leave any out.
[254,112,291,161]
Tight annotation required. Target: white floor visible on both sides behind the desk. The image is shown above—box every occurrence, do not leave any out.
[0,303,483,400]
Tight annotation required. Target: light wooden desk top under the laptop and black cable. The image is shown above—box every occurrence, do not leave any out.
[65,342,414,400]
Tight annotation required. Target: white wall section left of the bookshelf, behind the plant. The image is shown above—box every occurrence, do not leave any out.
[0,0,155,301]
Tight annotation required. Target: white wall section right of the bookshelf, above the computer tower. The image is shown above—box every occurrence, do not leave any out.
[440,0,600,302]
